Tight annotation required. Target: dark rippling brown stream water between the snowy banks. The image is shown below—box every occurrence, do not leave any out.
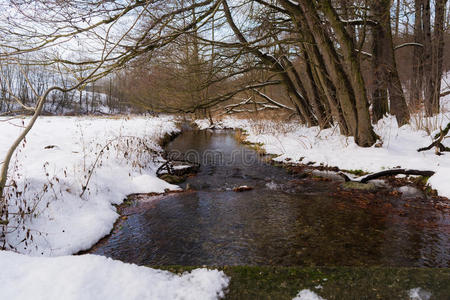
[95,131,450,267]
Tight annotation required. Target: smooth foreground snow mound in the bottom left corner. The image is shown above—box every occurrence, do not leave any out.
[0,251,229,300]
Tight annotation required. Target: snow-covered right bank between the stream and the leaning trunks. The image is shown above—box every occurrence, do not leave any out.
[196,97,450,198]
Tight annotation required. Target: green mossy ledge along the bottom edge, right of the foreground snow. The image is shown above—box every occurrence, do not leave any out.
[150,266,450,300]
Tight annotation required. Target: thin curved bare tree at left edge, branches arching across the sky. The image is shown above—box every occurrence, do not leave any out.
[0,0,220,229]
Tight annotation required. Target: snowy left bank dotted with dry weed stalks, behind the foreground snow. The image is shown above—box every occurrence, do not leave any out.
[0,117,179,255]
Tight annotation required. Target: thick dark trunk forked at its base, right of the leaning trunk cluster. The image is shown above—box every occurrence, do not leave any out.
[371,0,409,126]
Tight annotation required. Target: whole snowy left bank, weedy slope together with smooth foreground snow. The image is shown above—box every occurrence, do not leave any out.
[0,116,236,300]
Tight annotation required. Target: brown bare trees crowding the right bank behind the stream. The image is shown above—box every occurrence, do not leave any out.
[101,0,450,146]
